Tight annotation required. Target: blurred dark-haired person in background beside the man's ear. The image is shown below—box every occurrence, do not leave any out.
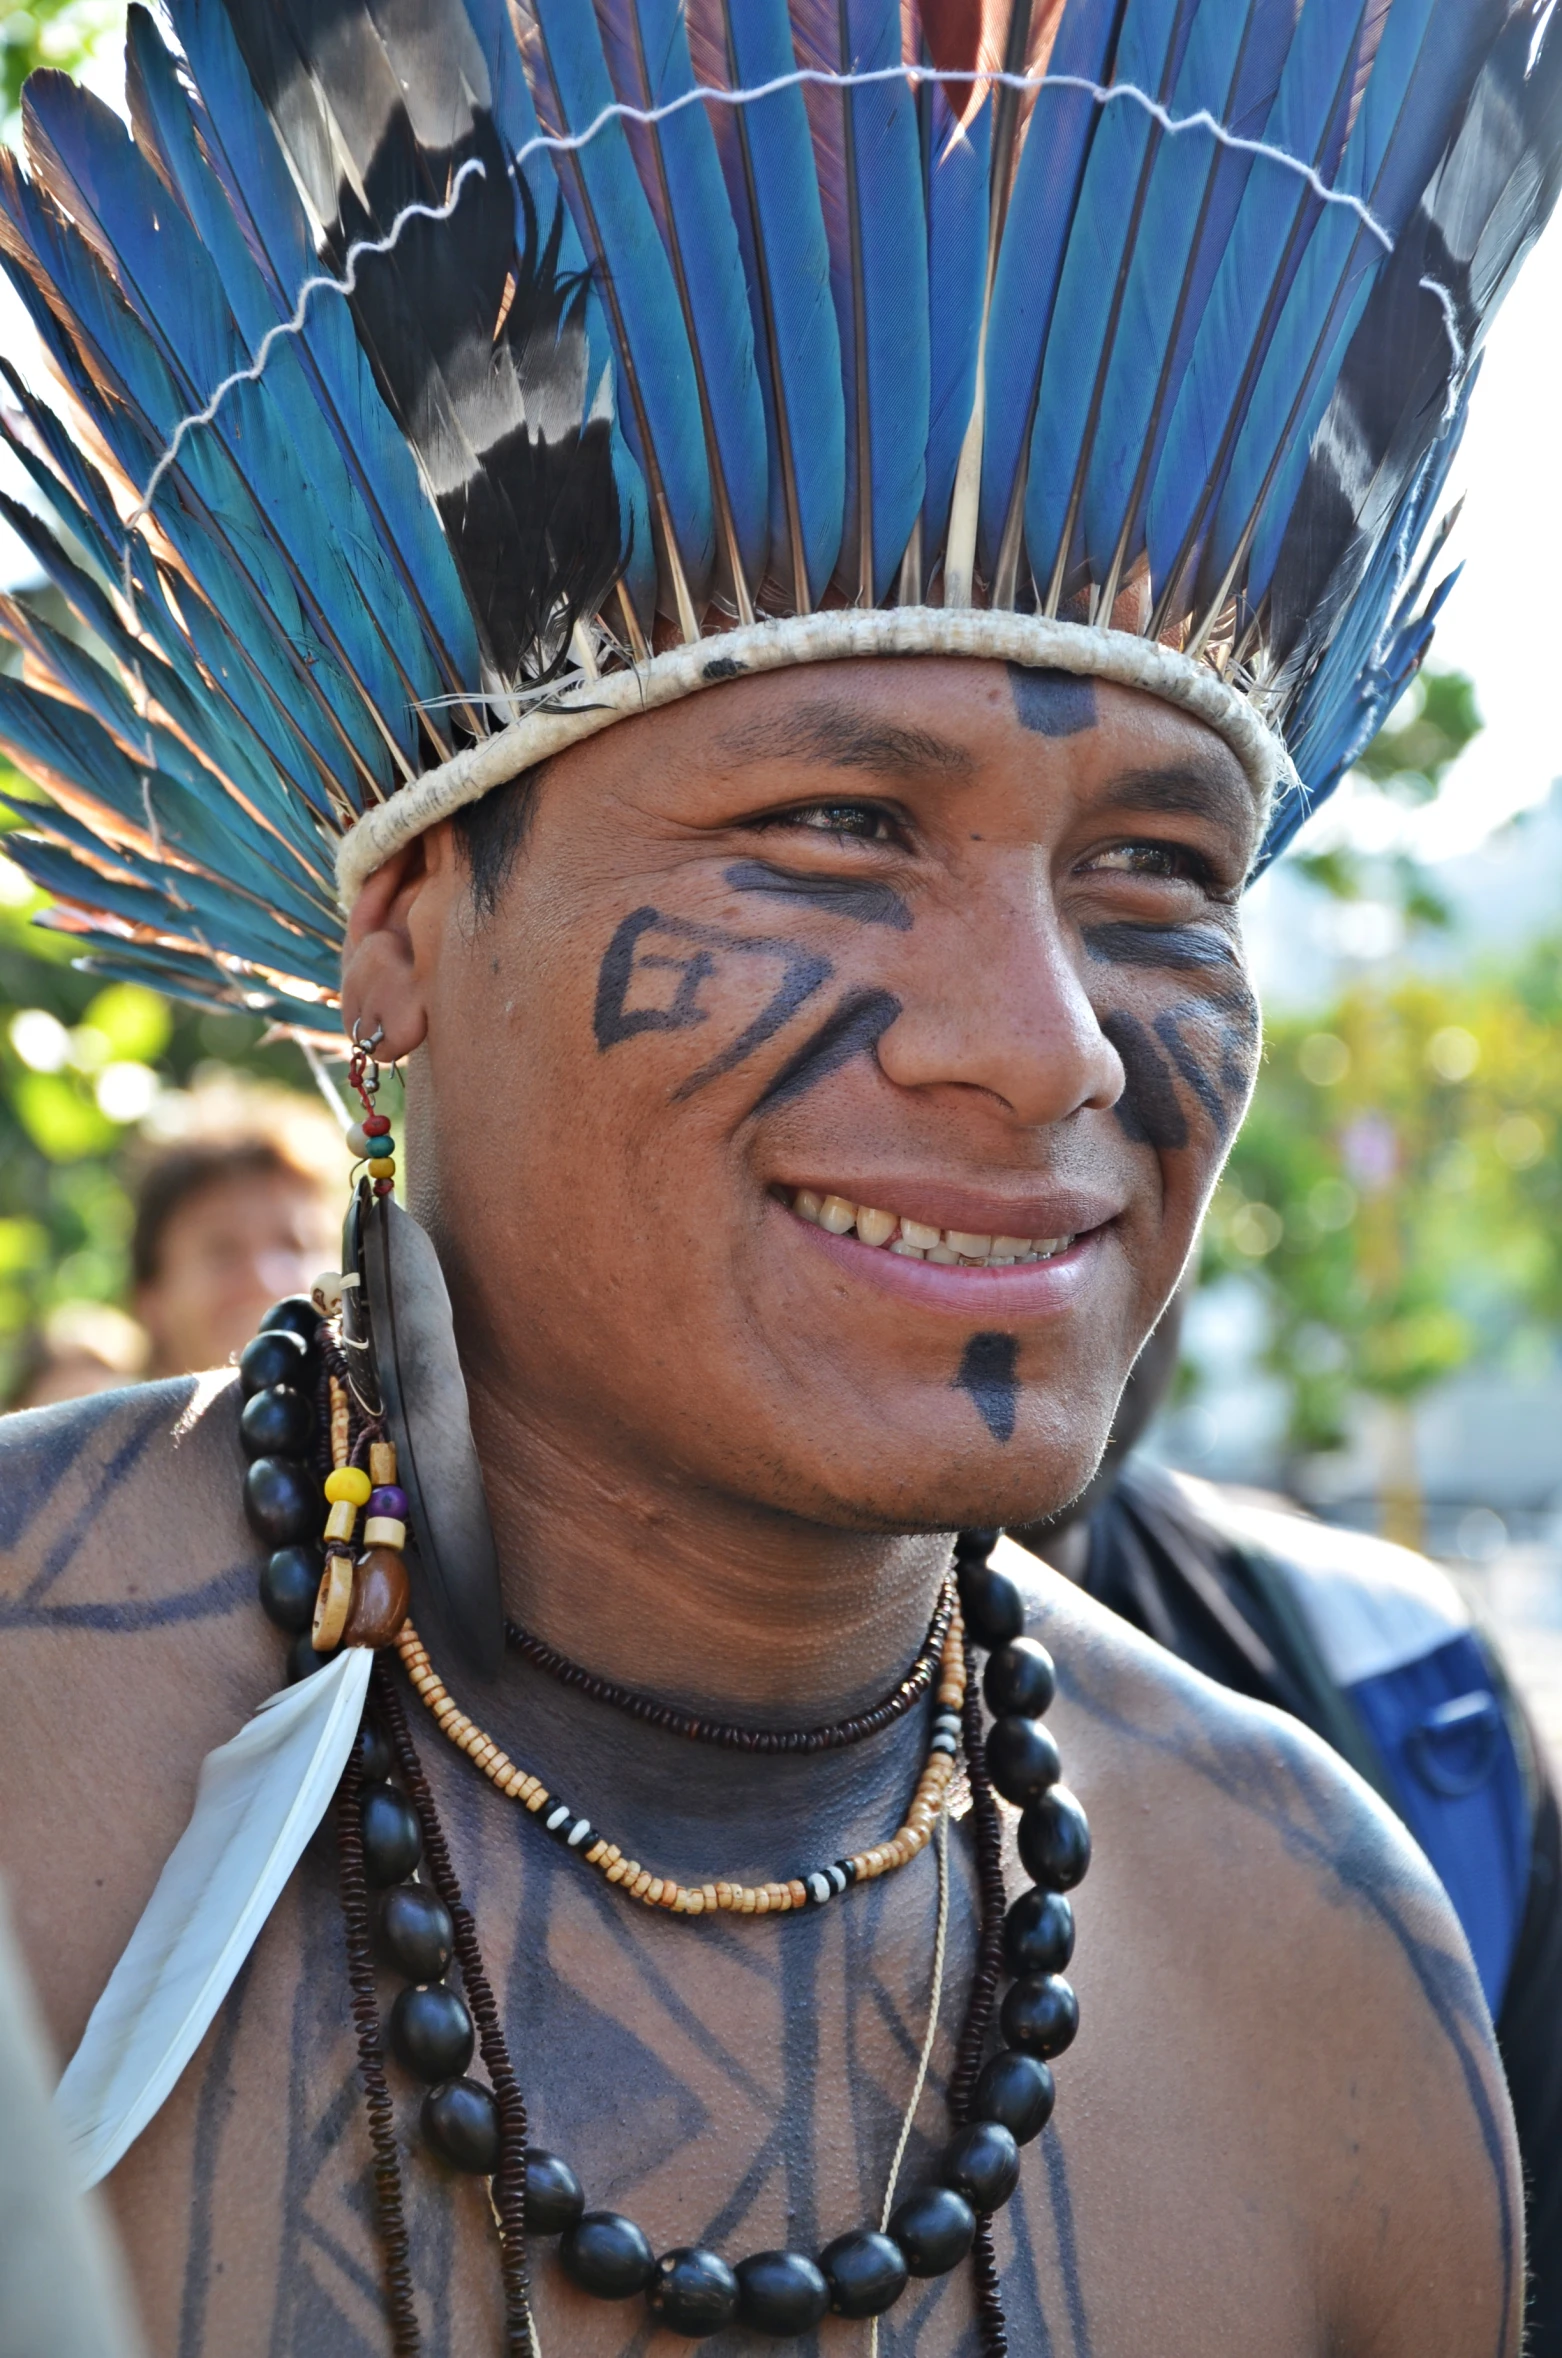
[130,1082,349,1375]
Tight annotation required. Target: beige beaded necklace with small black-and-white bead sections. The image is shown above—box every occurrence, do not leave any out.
[396,1603,965,1917]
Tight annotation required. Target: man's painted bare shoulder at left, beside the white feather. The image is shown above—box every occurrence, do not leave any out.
[0,1375,281,2044]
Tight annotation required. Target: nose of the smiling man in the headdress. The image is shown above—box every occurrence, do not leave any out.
[878,870,1125,1127]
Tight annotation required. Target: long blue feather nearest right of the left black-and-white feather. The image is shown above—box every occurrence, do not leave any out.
[514,0,715,634]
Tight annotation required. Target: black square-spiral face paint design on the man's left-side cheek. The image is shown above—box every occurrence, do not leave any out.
[592,908,833,1096]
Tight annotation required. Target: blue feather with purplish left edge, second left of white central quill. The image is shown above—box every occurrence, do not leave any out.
[790,0,930,604]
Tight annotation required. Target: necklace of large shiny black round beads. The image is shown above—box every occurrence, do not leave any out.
[241,1297,1090,2358]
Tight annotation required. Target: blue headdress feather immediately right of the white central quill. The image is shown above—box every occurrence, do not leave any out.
[982,0,1123,587]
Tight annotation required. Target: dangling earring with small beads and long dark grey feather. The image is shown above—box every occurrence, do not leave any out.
[342,1023,505,1677]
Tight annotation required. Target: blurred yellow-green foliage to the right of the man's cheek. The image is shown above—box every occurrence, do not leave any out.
[1206,943,1562,1453]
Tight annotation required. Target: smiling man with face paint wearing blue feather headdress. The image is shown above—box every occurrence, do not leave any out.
[0,0,1560,2358]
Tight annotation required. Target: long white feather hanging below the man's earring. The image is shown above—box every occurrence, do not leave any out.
[54,1646,375,2186]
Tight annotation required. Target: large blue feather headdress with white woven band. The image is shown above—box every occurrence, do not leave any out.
[0,0,1562,1028]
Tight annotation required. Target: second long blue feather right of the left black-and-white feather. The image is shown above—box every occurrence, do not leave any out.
[597,0,769,620]
